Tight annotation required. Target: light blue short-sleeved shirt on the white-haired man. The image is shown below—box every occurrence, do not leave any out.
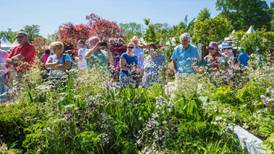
[171,44,200,73]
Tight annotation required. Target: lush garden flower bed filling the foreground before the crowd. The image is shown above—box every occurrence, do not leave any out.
[0,63,274,154]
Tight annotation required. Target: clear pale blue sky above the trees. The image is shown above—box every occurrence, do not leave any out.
[0,0,271,36]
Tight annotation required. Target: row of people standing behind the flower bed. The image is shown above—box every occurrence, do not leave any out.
[0,32,256,101]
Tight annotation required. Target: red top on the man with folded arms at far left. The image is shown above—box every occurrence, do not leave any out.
[9,43,36,71]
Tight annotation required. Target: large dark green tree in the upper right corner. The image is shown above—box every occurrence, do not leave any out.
[216,0,271,30]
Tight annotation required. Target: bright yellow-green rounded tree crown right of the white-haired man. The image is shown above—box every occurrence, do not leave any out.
[193,17,232,45]
